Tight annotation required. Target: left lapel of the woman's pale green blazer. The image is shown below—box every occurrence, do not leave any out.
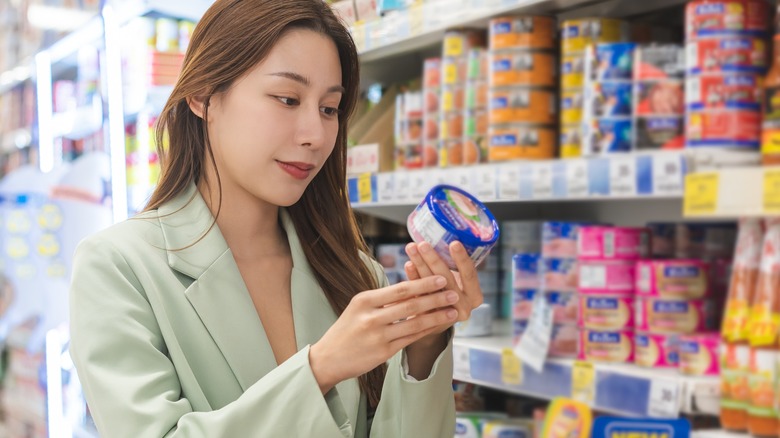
[158,184,276,391]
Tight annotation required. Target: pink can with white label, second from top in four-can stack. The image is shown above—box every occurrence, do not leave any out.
[578,260,636,295]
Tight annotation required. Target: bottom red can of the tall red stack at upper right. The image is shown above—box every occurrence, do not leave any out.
[685,109,761,149]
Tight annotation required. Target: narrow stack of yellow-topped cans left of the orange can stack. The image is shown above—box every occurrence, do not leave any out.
[439,29,485,167]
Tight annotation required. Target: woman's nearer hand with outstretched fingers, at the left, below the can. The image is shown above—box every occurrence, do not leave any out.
[309,275,458,394]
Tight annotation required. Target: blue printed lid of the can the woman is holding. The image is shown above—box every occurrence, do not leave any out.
[425,185,499,246]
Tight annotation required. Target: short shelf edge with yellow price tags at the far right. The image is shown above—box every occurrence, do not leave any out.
[684,166,780,219]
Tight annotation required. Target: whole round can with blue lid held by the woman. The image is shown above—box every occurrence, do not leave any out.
[406,185,499,270]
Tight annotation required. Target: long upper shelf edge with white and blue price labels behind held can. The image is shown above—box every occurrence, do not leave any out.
[349,149,759,225]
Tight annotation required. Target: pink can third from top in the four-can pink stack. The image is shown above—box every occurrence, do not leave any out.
[579,294,634,330]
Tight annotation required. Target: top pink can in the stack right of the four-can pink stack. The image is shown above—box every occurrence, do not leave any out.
[636,260,711,299]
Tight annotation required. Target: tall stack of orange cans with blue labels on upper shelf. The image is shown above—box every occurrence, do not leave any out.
[488,16,557,161]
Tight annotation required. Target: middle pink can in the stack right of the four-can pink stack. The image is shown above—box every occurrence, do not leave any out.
[634,298,714,334]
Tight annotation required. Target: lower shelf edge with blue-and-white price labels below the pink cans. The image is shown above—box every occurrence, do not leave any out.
[453,321,720,418]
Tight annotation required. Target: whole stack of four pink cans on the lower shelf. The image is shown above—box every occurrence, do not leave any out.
[578,226,650,363]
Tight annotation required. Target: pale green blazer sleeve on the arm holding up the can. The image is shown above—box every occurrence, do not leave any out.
[369,263,455,438]
